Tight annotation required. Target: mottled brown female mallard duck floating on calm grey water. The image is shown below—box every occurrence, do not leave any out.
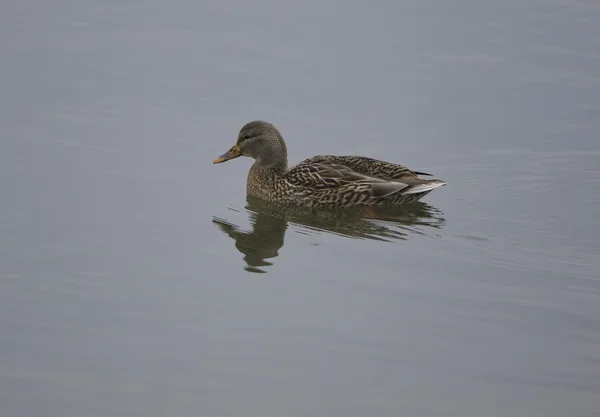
[214,121,446,207]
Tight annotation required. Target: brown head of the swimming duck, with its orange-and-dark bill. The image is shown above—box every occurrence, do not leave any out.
[214,120,287,166]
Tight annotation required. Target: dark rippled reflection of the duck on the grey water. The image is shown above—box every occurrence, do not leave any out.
[213,196,445,273]
